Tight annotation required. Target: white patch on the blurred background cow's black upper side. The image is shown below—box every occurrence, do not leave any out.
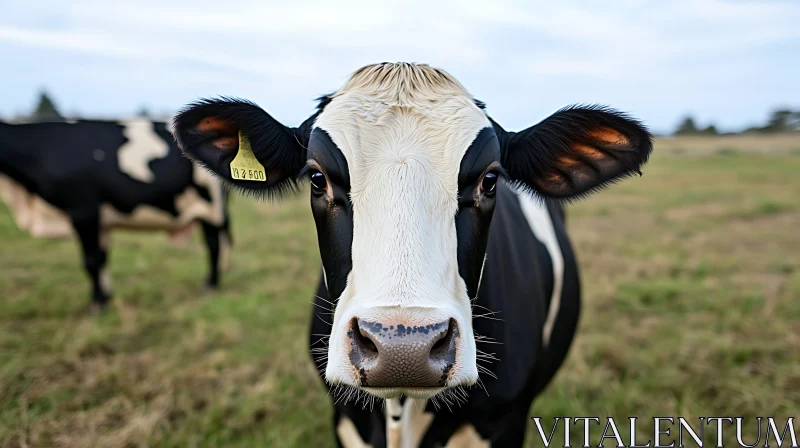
[117,119,169,183]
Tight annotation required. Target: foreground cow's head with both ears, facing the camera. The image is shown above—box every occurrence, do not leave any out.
[175,63,651,398]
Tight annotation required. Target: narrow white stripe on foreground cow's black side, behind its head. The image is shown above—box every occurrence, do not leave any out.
[517,191,564,347]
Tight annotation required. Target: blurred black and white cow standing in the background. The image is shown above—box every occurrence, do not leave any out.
[0,119,230,308]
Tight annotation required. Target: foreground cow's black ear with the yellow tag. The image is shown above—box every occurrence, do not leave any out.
[173,98,315,196]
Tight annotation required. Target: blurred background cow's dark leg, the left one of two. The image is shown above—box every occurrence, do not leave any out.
[72,212,111,308]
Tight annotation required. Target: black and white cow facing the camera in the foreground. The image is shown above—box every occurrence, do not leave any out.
[175,63,651,447]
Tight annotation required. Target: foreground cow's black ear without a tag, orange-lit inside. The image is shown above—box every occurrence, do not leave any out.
[492,106,653,200]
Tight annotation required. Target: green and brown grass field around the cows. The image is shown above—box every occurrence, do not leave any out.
[0,138,800,447]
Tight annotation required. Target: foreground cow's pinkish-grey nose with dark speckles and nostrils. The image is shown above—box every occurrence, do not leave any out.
[347,318,458,387]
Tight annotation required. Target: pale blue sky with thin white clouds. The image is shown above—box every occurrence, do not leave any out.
[0,0,800,132]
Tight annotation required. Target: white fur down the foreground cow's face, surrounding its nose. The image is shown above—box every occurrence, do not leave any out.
[315,65,491,386]
